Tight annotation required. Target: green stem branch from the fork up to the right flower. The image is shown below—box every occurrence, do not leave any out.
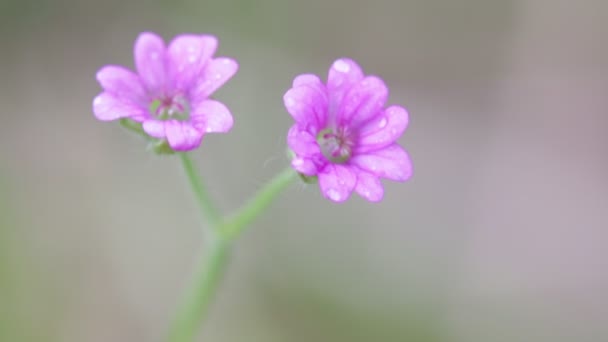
[219,167,298,240]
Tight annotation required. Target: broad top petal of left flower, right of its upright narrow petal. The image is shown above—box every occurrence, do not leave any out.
[167,34,218,90]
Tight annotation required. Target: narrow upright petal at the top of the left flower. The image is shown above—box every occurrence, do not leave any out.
[134,32,167,97]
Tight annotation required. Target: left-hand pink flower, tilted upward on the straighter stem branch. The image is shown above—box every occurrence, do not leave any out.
[93,32,238,151]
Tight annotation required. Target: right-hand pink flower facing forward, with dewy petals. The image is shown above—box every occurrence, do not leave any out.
[283,59,412,202]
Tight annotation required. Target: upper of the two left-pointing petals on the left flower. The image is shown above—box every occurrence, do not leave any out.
[96,65,146,106]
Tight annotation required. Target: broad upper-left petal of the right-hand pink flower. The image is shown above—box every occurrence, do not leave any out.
[283,84,327,134]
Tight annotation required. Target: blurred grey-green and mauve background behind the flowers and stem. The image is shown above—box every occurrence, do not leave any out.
[0,0,608,342]
